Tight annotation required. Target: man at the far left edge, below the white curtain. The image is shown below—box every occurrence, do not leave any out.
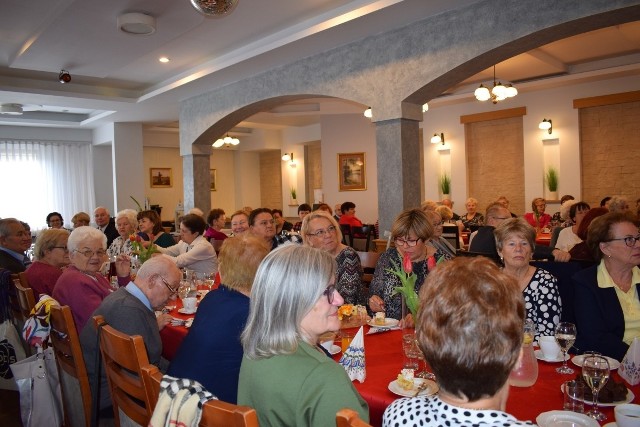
[0,218,31,273]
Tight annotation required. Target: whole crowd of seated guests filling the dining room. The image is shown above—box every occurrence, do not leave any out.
[0,195,640,426]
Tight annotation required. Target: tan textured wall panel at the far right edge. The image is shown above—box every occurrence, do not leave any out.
[580,102,640,207]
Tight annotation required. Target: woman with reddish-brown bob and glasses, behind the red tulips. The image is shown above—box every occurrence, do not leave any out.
[369,209,433,324]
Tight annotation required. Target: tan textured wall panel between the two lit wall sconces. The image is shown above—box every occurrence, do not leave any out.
[458,117,525,214]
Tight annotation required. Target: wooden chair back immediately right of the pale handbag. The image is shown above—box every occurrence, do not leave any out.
[50,305,91,427]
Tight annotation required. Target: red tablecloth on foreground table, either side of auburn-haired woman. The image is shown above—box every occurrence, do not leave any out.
[335,326,640,426]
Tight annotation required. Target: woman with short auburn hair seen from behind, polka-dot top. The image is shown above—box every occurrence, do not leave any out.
[382,257,531,427]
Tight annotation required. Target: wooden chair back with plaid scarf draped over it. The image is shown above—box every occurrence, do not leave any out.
[142,365,258,427]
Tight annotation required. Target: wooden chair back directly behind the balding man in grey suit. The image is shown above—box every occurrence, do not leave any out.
[93,316,153,426]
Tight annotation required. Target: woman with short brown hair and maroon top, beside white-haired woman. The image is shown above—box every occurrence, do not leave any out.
[26,228,71,301]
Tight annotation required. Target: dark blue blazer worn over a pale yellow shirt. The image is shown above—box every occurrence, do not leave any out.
[573,265,640,361]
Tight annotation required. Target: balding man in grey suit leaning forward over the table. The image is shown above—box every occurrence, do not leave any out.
[80,255,182,409]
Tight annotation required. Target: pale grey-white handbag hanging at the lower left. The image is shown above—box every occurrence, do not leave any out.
[11,348,63,427]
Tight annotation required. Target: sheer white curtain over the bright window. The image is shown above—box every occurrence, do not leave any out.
[0,139,95,230]
